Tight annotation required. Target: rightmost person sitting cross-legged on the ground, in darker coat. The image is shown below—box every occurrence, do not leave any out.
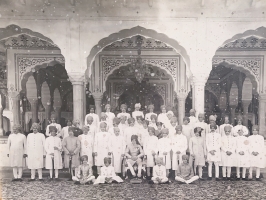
[175,155,199,184]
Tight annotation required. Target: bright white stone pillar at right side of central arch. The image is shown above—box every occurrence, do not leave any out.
[192,79,206,117]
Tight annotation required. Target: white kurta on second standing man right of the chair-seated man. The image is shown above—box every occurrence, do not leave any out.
[158,137,171,169]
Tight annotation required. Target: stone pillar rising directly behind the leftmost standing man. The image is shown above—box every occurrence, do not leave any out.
[8,91,20,126]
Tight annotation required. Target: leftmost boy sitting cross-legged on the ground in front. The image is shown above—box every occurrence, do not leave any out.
[72,155,95,184]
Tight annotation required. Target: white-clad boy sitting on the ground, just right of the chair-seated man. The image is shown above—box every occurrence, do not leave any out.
[149,157,168,184]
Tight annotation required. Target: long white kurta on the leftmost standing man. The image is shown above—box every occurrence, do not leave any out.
[7,133,27,167]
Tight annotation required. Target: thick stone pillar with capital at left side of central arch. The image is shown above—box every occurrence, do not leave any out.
[68,72,85,126]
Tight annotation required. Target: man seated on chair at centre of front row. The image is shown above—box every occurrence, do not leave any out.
[125,135,144,178]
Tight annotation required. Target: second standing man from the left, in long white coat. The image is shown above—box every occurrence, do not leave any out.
[27,123,46,181]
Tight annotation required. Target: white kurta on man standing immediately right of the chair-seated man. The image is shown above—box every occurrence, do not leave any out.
[143,135,158,167]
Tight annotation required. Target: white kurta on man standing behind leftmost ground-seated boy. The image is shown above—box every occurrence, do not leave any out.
[78,134,93,166]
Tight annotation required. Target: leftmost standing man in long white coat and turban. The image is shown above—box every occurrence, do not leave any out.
[7,125,27,181]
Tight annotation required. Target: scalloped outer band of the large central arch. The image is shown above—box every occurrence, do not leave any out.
[86,26,191,79]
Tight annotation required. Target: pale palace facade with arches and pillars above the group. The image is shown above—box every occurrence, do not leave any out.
[0,0,266,139]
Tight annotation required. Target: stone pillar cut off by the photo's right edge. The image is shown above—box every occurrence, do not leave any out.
[259,94,266,138]
